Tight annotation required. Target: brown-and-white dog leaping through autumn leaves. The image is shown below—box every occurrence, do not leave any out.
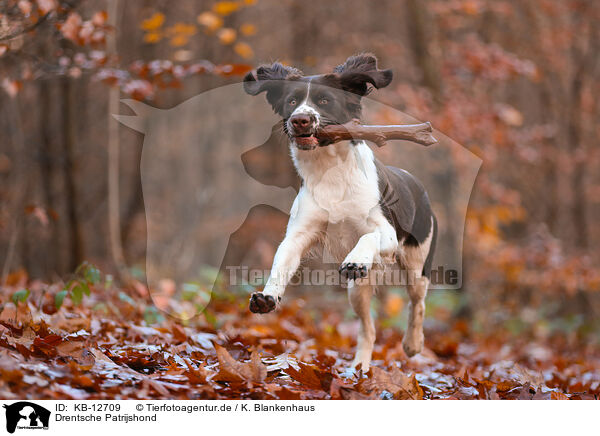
[243,53,437,371]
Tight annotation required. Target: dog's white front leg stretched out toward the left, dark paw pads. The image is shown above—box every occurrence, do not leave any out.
[250,189,327,313]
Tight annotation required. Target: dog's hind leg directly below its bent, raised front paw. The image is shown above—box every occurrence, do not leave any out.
[348,280,375,372]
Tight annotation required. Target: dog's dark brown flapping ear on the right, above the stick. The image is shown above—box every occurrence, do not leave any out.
[333,53,394,96]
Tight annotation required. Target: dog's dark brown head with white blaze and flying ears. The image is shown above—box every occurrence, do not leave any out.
[244,54,392,150]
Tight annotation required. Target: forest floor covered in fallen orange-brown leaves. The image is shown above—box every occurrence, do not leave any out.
[0,275,600,399]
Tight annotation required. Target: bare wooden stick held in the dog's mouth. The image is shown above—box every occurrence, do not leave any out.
[316,120,438,147]
